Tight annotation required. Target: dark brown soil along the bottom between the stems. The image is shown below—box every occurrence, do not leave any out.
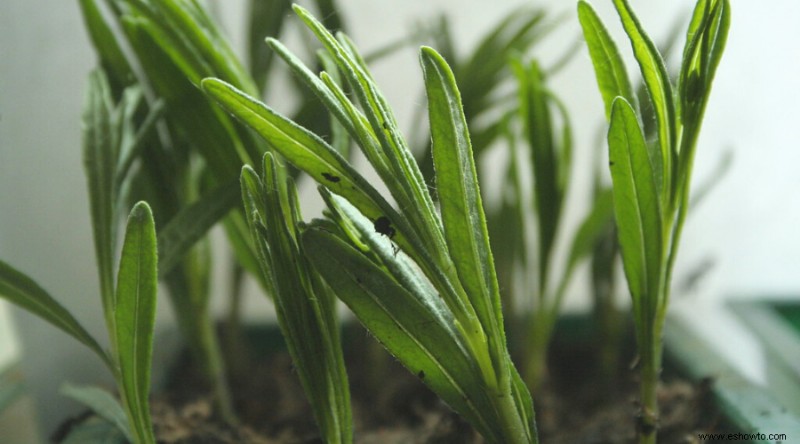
[54,324,732,444]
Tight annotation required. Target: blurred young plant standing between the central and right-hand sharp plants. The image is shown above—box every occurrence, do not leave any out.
[513,56,612,390]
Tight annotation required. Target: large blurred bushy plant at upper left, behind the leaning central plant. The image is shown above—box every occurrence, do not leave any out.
[80,0,350,419]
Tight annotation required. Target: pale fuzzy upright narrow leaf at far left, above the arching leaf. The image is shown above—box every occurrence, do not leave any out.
[82,70,120,313]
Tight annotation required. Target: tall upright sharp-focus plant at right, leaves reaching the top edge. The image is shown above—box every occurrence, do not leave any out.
[578,0,730,443]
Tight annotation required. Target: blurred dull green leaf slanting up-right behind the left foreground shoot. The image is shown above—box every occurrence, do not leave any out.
[158,181,240,276]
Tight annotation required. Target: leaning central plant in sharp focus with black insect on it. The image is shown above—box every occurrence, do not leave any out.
[202,6,537,443]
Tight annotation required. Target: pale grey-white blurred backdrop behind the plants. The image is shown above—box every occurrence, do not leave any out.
[0,0,800,443]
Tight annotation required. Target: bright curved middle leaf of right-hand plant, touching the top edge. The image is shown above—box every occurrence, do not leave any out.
[614,0,677,199]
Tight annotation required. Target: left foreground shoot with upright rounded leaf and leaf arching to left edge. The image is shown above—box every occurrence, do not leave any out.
[0,202,158,444]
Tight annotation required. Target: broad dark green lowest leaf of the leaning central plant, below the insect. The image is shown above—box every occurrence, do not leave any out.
[301,226,501,442]
